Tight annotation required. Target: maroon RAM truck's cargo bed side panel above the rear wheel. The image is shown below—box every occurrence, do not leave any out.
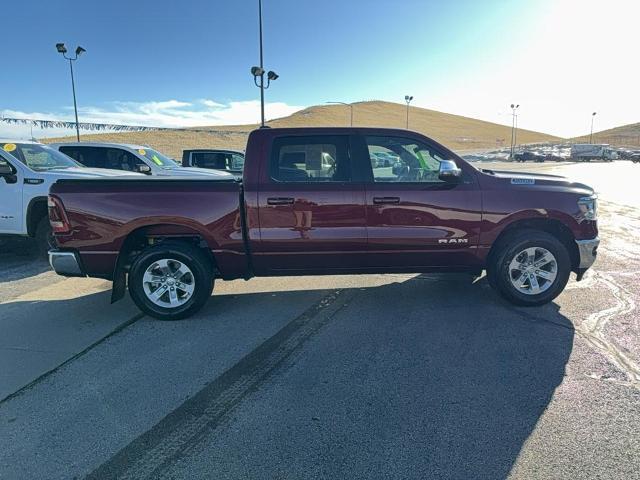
[50,177,246,279]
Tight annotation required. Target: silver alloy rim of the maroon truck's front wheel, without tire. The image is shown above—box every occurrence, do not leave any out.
[509,247,558,295]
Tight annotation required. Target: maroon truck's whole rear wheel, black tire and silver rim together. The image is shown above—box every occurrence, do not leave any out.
[129,242,213,320]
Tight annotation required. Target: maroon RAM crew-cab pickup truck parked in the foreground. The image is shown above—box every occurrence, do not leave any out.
[49,128,599,320]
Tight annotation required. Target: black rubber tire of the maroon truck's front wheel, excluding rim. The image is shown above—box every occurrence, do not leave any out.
[487,229,571,307]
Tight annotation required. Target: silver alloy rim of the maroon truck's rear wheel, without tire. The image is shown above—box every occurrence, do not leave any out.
[142,258,195,308]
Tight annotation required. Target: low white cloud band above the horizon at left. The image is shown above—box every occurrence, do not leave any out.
[0,99,304,139]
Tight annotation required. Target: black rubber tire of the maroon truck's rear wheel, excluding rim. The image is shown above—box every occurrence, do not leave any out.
[129,242,214,320]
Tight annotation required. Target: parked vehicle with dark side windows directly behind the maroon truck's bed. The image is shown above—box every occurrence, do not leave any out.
[51,142,235,177]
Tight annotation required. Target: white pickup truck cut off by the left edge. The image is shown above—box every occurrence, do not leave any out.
[0,139,140,254]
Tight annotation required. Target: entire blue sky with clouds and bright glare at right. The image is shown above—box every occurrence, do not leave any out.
[0,0,640,138]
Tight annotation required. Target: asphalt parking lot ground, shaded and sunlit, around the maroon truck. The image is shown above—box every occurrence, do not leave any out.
[0,161,640,479]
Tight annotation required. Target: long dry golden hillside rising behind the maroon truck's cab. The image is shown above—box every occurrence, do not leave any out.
[43,101,558,158]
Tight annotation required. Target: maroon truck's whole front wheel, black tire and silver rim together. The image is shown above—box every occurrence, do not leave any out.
[487,230,571,306]
